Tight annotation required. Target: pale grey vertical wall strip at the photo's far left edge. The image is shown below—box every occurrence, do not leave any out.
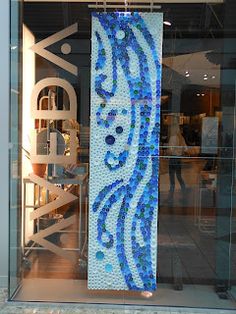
[0,0,9,287]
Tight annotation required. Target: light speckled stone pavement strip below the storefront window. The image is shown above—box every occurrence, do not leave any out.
[0,289,236,314]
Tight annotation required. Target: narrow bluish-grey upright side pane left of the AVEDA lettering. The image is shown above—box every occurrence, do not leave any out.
[6,1,21,295]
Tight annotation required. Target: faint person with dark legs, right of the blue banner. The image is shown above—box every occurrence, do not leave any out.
[167,116,187,202]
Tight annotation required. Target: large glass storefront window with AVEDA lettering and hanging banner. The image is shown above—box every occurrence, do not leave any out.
[10,0,236,308]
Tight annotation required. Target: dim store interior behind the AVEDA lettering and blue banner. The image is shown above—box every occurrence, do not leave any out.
[11,2,236,308]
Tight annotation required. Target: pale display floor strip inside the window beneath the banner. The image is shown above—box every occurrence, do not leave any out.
[12,278,236,309]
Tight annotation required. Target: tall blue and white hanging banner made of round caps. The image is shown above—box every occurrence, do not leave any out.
[88,12,163,291]
